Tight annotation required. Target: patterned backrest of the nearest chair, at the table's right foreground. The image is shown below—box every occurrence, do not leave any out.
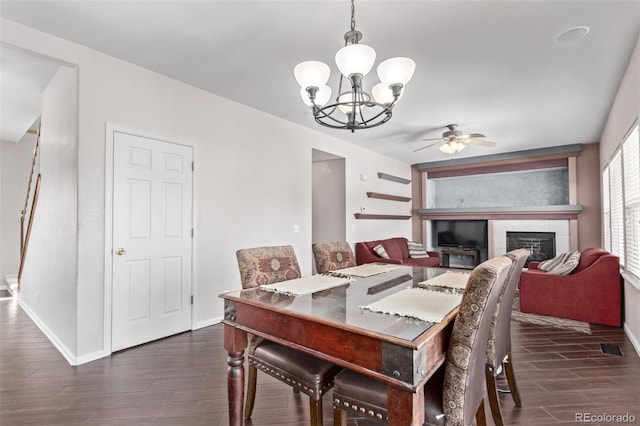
[442,257,512,426]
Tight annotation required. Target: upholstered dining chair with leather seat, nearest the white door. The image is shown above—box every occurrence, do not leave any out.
[236,246,341,426]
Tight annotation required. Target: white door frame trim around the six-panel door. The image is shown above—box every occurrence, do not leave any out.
[103,122,198,356]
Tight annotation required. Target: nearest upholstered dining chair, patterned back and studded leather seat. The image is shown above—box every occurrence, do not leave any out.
[333,257,512,426]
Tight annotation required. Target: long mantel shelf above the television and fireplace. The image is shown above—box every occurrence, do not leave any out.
[417,204,582,220]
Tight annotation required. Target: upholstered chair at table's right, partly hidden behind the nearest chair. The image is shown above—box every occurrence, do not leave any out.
[486,249,529,426]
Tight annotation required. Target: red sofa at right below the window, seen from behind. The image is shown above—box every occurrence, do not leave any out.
[520,248,622,327]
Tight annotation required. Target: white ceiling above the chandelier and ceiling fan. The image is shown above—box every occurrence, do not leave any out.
[0,0,640,164]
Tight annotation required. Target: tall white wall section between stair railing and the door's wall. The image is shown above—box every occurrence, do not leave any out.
[20,67,78,360]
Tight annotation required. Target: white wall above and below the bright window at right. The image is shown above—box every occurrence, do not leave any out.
[600,34,640,354]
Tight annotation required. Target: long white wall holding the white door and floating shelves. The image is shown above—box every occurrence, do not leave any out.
[0,20,411,361]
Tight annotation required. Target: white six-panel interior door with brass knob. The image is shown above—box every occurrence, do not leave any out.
[111,132,193,351]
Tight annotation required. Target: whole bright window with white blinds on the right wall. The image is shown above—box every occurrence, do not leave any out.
[602,124,640,278]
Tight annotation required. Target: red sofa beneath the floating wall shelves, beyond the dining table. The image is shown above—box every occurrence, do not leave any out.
[356,237,440,266]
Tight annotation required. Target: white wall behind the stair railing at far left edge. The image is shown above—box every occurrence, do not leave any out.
[0,134,36,286]
